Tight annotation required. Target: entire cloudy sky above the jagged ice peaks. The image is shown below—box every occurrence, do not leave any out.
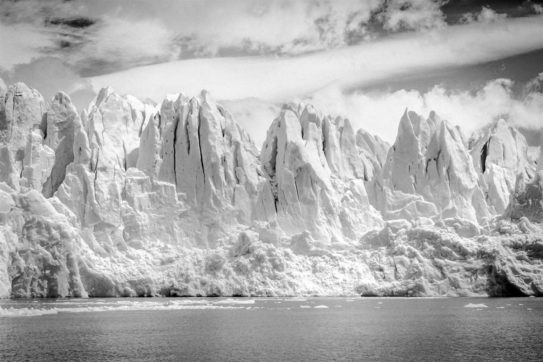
[0,0,543,146]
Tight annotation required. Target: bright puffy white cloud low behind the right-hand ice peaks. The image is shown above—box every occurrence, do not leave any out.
[225,79,543,146]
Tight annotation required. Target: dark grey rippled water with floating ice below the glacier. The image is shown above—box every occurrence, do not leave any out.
[0,298,543,361]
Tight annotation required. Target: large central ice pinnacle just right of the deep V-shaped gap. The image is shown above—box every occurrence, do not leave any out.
[257,106,382,244]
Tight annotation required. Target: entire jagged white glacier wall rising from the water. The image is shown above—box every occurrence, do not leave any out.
[0,84,543,297]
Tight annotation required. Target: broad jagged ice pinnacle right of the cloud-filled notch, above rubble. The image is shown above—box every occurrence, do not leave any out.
[382,110,488,224]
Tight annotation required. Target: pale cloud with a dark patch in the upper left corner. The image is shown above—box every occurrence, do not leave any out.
[0,0,179,72]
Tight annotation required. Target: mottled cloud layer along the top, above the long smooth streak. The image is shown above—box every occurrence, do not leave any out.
[0,0,454,74]
